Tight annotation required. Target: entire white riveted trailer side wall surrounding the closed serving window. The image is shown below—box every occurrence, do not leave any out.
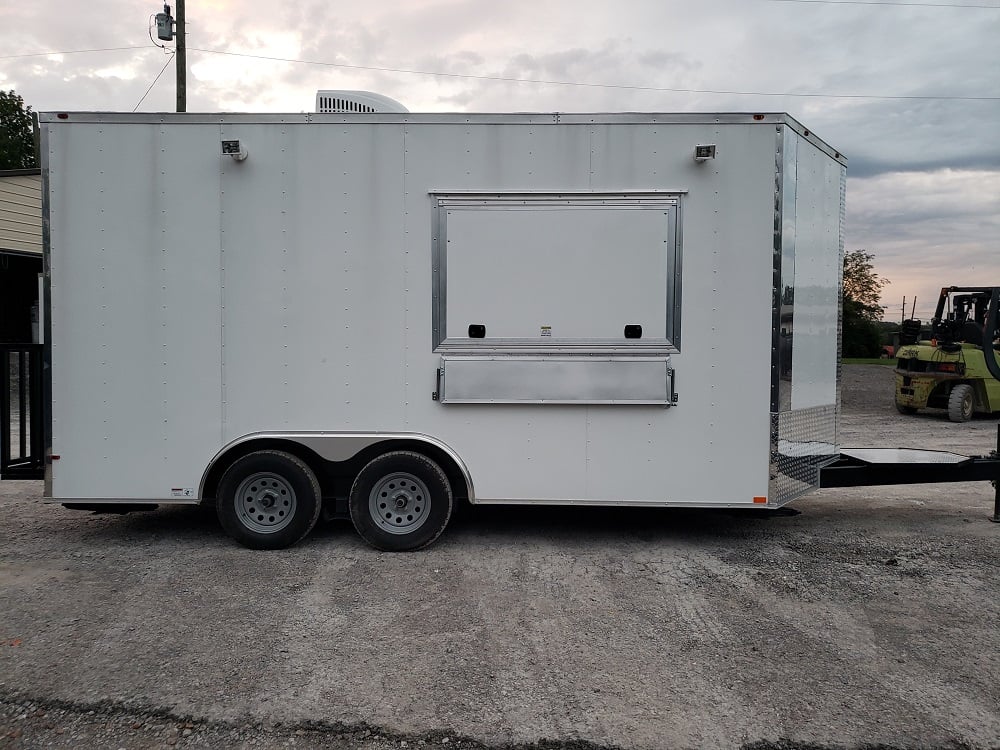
[48,116,839,505]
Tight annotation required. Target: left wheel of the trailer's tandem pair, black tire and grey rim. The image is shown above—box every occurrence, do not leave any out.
[215,450,322,549]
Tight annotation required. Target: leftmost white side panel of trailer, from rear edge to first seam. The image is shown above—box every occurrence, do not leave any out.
[47,123,222,498]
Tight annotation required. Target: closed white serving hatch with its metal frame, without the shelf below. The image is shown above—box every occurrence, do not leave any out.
[431,192,680,354]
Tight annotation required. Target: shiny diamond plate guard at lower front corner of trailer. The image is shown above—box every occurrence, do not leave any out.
[768,404,838,506]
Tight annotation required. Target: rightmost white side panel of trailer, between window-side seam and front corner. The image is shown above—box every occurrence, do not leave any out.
[587,124,776,504]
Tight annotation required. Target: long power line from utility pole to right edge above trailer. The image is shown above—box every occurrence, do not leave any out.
[188,47,1000,102]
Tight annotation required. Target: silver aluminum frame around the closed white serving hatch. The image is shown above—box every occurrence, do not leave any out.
[429,190,686,355]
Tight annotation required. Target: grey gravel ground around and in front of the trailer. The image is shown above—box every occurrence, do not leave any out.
[0,366,1000,750]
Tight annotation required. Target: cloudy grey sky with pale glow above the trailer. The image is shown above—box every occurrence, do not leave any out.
[0,0,1000,320]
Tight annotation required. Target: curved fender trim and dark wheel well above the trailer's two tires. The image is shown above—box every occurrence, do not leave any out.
[198,432,476,503]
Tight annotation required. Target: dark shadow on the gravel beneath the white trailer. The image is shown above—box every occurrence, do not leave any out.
[57,495,992,549]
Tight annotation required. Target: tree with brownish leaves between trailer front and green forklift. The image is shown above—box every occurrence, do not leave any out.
[843,250,889,357]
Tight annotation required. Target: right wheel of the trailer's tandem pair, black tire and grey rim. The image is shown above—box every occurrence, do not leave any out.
[350,451,453,552]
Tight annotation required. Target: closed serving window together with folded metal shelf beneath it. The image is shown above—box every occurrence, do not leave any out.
[431,192,681,406]
